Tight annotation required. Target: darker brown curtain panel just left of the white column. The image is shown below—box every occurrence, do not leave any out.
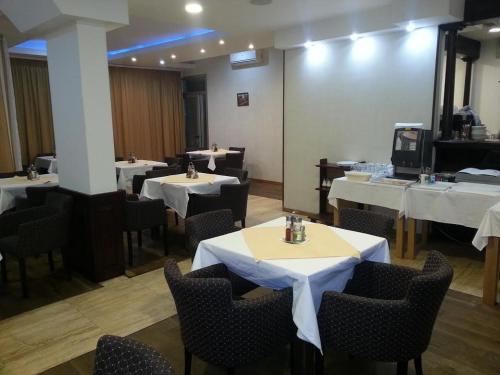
[11,59,55,165]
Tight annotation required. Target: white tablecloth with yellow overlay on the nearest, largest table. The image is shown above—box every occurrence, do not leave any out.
[192,217,390,350]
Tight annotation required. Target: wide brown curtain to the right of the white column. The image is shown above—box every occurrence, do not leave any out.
[109,67,185,160]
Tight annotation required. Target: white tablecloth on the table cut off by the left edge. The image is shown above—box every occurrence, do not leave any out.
[0,174,59,214]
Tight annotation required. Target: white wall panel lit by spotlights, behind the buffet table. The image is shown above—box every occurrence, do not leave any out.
[284,28,437,212]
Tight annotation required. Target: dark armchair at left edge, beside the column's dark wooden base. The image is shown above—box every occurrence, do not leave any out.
[0,192,73,297]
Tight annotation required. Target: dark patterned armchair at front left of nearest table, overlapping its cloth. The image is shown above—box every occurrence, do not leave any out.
[165,259,296,375]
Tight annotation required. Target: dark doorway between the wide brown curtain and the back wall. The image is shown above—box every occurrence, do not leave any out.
[182,75,208,151]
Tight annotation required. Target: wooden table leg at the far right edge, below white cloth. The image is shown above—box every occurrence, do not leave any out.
[483,237,500,306]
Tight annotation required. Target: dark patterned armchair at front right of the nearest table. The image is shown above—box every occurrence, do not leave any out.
[317,251,453,375]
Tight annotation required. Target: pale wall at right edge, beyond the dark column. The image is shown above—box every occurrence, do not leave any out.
[471,40,500,134]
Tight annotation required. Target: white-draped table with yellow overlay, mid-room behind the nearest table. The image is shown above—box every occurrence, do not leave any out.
[140,173,240,218]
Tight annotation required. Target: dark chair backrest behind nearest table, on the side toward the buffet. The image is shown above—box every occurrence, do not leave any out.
[340,208,394,238]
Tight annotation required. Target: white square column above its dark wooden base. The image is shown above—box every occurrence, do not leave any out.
[47,20,116,194]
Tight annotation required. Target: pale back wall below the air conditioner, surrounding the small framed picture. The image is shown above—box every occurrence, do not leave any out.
[184,49,283,182]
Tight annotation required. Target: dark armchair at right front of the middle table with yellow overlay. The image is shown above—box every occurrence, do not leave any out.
[188,181,250,228]
